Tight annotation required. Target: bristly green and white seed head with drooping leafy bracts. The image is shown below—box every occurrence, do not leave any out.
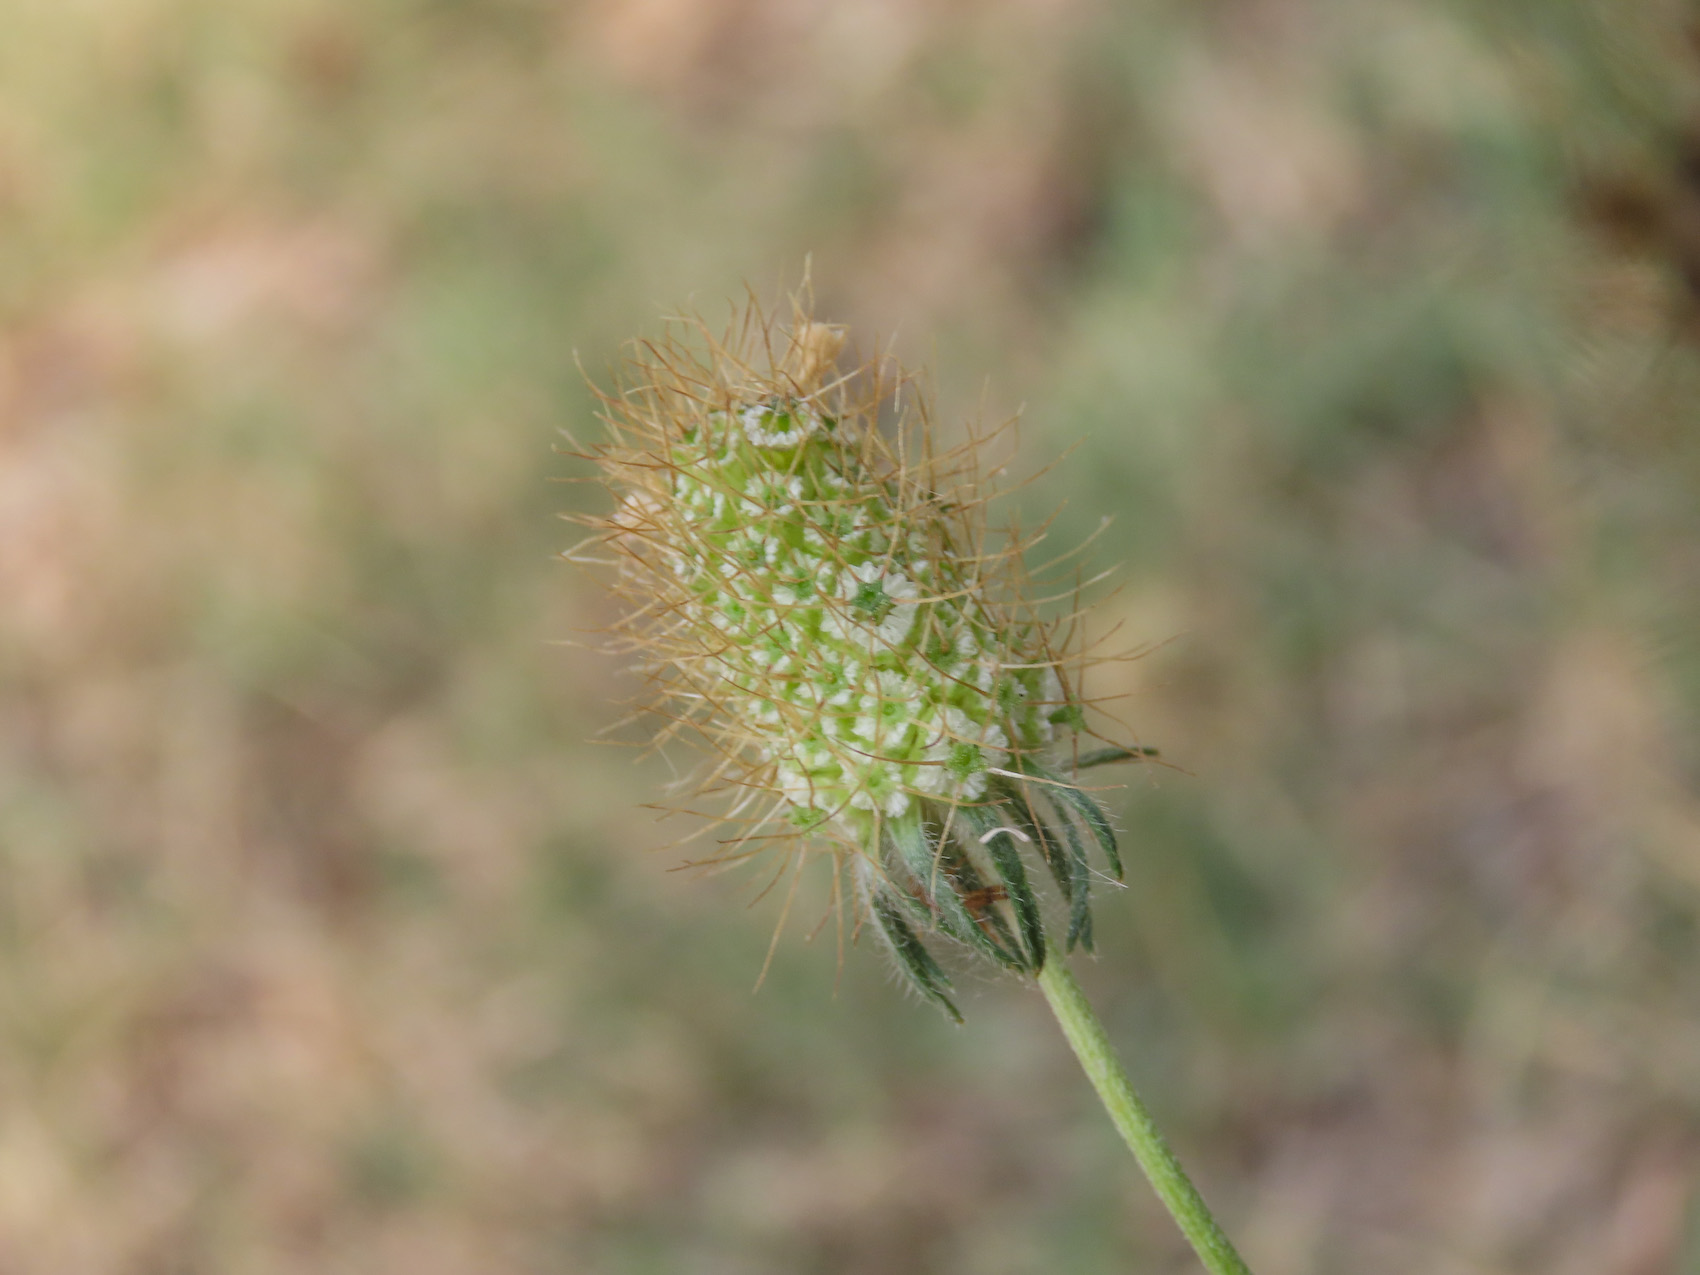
[588,294,1144,1015]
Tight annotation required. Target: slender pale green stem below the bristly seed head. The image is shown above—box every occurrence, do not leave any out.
[1039,955,1251,1275]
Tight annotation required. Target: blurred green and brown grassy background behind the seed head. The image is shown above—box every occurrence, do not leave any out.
[0,0,1700,1275]
